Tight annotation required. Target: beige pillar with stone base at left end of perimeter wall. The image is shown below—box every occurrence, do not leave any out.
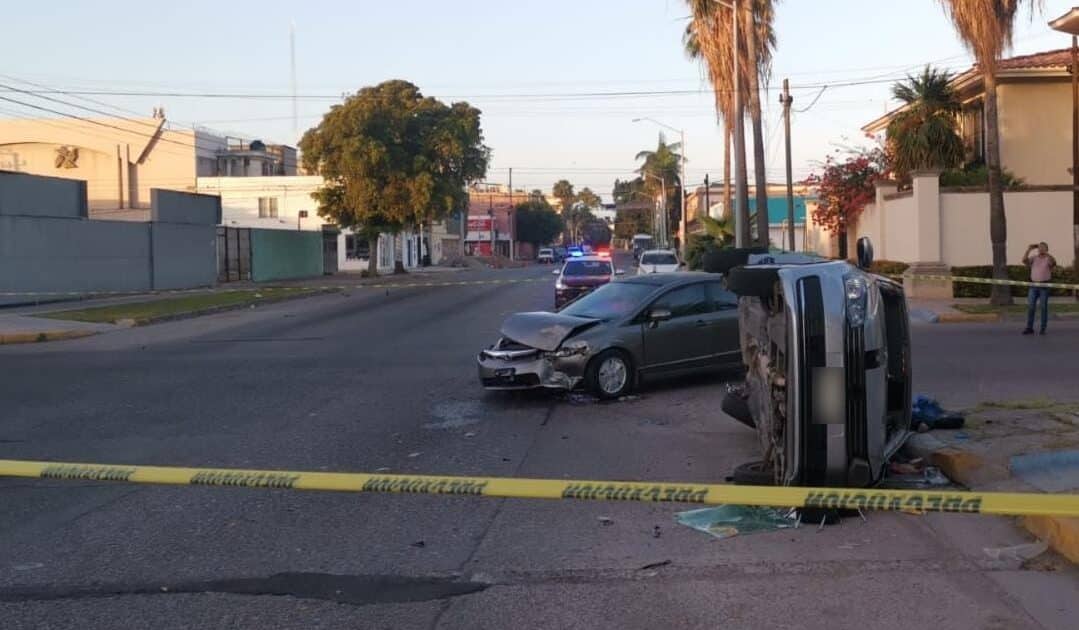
[903,170,952,300]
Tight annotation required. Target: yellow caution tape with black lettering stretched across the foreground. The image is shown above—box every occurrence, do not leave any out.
[0,460,1079,517]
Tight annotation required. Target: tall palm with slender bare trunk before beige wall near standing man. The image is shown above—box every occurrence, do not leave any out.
[940,0,1044,304]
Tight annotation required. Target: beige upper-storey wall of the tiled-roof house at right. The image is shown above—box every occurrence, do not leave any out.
[997,81,1071,184]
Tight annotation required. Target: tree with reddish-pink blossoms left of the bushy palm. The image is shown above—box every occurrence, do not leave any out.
[806,149,887,258]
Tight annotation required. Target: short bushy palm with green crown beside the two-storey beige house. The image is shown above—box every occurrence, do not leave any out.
[886,66,964,180]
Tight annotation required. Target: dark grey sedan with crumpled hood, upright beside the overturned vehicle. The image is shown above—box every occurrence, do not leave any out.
[477,272,741,398]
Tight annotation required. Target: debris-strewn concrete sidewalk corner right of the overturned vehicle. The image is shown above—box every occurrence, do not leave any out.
[907,400,1079,564]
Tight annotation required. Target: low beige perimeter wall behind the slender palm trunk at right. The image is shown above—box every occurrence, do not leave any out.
[941,192,1073,266]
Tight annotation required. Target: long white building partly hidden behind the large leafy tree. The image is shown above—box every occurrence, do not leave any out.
[196,175,456,272]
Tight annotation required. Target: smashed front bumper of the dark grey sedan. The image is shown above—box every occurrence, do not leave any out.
[476,344,588,389]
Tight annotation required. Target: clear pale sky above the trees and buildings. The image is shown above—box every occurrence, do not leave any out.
[0,0,1070,196]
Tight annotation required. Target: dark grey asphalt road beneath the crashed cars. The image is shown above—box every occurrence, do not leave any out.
[0,258,1079,630]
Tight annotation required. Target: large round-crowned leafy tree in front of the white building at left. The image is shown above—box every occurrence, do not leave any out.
[300,81,490,274]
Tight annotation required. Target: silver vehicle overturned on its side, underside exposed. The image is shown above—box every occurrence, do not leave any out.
[710,239,911,487]
